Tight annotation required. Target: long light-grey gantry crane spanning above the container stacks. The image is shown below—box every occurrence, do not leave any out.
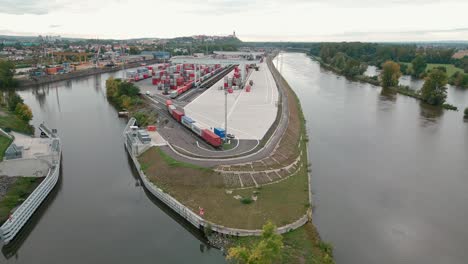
[170,56,259,84]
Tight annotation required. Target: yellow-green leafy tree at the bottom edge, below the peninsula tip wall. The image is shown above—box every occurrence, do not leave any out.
[227,222,283,264]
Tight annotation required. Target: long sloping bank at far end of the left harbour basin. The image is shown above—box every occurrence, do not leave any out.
[18,60,158,88]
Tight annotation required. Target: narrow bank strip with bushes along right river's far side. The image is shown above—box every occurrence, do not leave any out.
[309,55,458,111]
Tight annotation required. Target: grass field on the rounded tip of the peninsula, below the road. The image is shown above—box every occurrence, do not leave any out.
[139,147,309,229]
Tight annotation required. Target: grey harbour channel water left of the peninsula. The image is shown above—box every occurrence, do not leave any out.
[0,72,224,264]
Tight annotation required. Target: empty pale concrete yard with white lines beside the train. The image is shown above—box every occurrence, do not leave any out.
[184,63,278,140]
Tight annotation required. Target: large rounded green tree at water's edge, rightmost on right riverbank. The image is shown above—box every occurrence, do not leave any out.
[421,69,448,105]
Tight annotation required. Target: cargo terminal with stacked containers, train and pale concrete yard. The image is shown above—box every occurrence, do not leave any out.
[132,52,279,157]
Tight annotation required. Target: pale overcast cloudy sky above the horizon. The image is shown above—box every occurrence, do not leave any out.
[0,0,468,41]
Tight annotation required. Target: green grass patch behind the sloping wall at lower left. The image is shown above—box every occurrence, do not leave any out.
[0,177,44,224]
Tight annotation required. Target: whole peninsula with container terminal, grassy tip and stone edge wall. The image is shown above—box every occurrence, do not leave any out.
[123,52,312,241]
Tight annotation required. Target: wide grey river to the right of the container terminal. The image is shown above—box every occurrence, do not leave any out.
[275,53,468,264]
